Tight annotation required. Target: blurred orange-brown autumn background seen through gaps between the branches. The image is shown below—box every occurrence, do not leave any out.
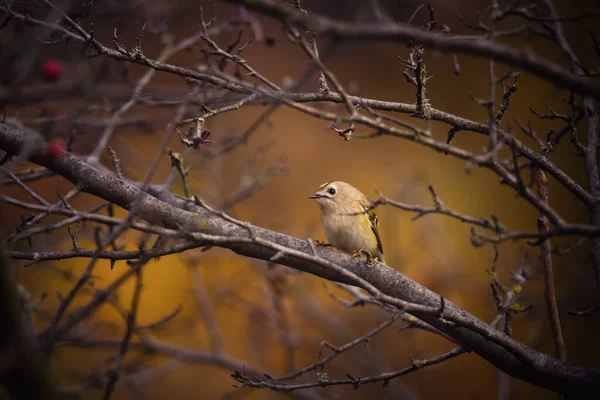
[0,0,600,399]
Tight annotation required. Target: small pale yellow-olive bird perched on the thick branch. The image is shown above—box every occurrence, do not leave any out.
[308,181,385,263]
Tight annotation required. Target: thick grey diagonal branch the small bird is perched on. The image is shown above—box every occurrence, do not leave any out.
[0,124,600,394]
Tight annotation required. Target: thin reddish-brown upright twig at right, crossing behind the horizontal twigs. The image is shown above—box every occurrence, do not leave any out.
[534,166,567,361]
